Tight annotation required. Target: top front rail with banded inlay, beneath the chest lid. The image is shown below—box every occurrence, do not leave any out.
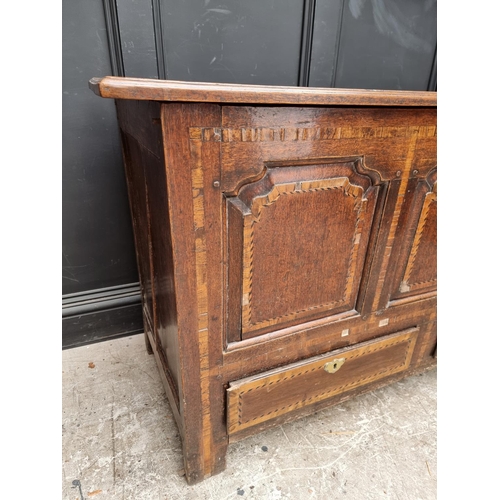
[221,106,436,192]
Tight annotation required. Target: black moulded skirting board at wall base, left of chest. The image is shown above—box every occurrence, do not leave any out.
[62,283,144,349]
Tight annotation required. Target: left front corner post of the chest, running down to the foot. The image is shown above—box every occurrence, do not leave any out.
[162,103,227,484]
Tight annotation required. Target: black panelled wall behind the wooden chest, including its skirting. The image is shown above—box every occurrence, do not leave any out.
[62,0,436,348]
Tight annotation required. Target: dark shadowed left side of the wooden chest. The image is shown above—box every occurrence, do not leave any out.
[117,101,180,408]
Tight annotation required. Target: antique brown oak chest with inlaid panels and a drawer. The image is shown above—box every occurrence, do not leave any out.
[91,77,437,483]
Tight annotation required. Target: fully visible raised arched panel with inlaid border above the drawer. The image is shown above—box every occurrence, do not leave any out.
[227,158,379,339]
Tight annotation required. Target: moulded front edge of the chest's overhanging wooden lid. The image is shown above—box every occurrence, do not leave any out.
[89,76,437,107]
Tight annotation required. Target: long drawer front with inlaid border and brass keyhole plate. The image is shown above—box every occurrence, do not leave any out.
[227,327,419,434]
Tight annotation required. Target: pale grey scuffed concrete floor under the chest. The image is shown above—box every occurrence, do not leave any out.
[62,335,437,500]
